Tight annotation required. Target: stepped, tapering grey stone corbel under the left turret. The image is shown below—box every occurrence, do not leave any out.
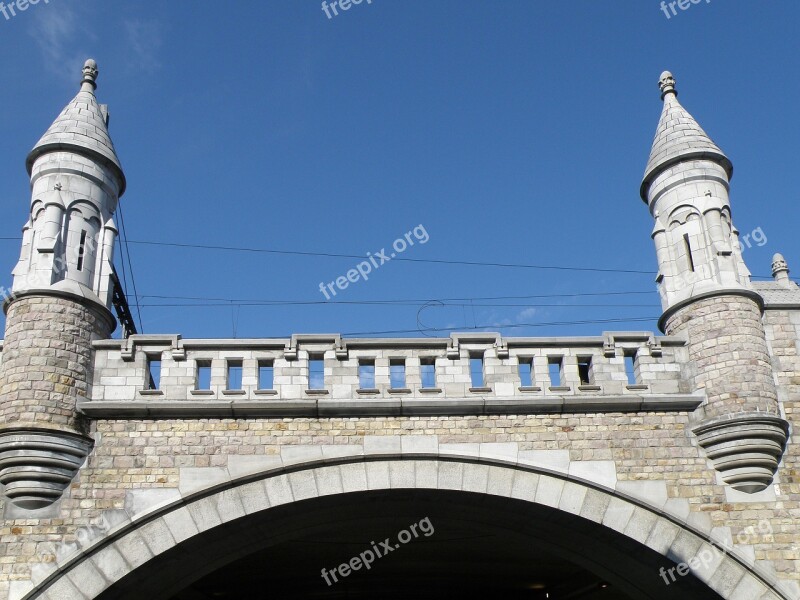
[0,429,94,510]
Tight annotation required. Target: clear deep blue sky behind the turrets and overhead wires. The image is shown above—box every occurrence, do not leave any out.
[0,0,800,337]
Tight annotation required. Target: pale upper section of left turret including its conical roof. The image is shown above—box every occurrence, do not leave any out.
[13,59,125,315]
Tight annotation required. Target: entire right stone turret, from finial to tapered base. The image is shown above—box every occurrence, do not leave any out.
[640,71,788,492]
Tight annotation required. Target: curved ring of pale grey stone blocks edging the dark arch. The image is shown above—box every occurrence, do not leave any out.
[18,456,790,600]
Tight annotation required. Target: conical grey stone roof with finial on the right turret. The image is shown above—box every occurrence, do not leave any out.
[640,71,733,202]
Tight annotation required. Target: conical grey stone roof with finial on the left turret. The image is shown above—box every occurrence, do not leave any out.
[26,59,125,196]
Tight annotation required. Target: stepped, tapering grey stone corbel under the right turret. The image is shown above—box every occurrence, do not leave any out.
[692,413,789,494]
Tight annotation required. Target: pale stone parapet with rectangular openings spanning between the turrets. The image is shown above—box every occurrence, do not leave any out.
[73,332,703,418]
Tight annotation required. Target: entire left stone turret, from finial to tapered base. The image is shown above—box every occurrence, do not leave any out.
[0,60,125,509]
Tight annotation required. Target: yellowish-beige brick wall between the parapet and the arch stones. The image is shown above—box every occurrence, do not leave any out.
[0,412,800,597]
